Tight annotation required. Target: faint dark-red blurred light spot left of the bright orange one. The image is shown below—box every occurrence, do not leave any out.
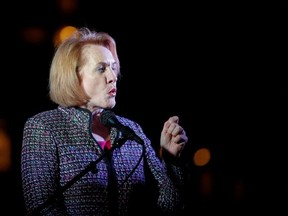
[22,27,46,44]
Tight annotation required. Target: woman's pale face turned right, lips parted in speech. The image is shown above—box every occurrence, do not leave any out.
[79,44,118,112]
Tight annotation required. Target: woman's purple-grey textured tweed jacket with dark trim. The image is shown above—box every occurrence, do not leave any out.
[21,107,184,216]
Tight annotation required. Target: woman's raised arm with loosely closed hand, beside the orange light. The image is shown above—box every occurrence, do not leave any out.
[137,117,188,216]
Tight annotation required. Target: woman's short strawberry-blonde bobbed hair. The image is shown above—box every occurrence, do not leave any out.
[49,27,120,107]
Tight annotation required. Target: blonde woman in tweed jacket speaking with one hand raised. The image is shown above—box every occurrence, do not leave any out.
[21,28,188,216]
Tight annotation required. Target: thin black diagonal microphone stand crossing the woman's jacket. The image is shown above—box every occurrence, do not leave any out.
[26,137,127,216]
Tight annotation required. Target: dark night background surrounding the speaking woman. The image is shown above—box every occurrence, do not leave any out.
[0,0,288,215]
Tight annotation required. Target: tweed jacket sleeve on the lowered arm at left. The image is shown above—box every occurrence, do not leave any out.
[21,118,65,215]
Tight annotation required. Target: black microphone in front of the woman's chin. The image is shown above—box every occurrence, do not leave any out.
[100,110,144,145]
